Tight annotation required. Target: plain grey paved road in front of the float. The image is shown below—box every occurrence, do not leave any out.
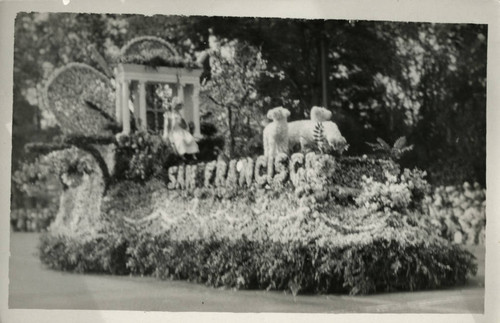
[9,233,484,313]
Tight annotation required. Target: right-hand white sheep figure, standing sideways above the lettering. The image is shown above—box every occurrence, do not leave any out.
[288,107,347,152]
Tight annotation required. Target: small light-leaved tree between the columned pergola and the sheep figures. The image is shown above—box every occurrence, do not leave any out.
[203,37,276,157]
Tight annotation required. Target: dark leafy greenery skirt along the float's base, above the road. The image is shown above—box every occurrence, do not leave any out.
[40,227,477,294]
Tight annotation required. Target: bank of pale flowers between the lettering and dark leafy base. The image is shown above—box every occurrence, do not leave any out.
[118,166,443,252]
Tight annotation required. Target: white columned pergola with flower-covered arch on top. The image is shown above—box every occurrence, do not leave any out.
[116,36,202,138]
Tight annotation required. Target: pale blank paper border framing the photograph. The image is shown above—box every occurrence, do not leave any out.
[0,0,500,323]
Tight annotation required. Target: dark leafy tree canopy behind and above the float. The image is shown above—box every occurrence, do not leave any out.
[14,13,488,184]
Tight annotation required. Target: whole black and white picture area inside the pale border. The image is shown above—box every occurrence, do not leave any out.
[2,1,498,321]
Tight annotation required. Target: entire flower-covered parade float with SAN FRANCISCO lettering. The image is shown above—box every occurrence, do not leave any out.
[17,37,480,295]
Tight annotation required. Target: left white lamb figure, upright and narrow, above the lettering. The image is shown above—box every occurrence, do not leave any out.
[262,107,290,157]
